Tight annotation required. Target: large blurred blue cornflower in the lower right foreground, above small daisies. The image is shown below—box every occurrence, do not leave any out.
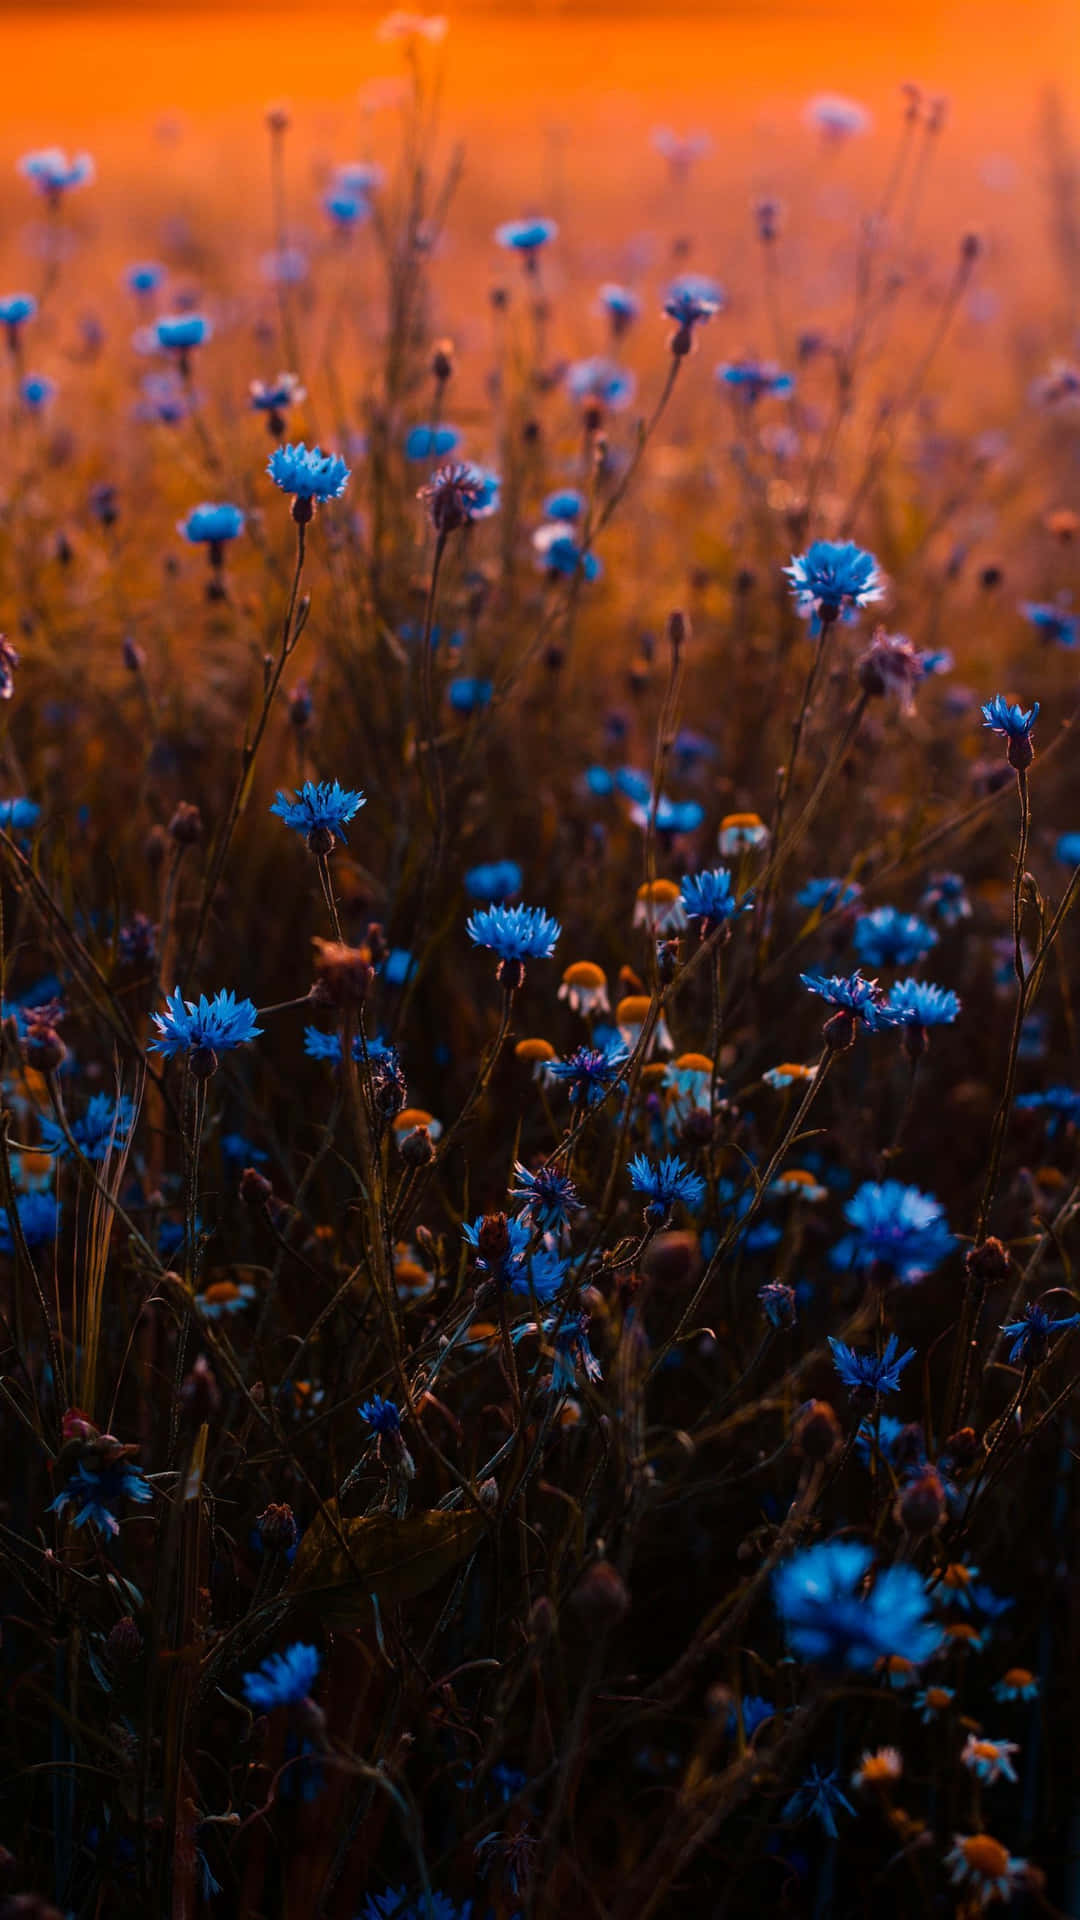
[773,1540,942,1672]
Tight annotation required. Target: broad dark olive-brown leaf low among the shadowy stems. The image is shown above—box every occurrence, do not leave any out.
[286,1500,484,1624]
